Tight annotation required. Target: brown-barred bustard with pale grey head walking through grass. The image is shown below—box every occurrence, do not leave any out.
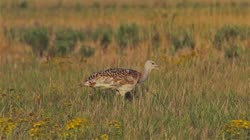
[83,60,159,96]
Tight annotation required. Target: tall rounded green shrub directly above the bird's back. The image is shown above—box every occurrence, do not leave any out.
[116,24,139,48]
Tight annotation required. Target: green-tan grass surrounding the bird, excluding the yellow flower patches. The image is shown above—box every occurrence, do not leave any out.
[0,54,250,139]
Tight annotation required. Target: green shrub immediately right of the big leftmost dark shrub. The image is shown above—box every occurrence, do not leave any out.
[55,28,78,55]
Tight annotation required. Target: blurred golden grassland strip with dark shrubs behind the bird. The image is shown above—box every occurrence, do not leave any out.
[0,0,250,63]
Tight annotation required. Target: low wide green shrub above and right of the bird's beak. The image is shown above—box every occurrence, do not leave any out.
[170,30,195,51]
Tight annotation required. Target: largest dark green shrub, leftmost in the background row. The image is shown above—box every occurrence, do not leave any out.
[20,27,49,56]
